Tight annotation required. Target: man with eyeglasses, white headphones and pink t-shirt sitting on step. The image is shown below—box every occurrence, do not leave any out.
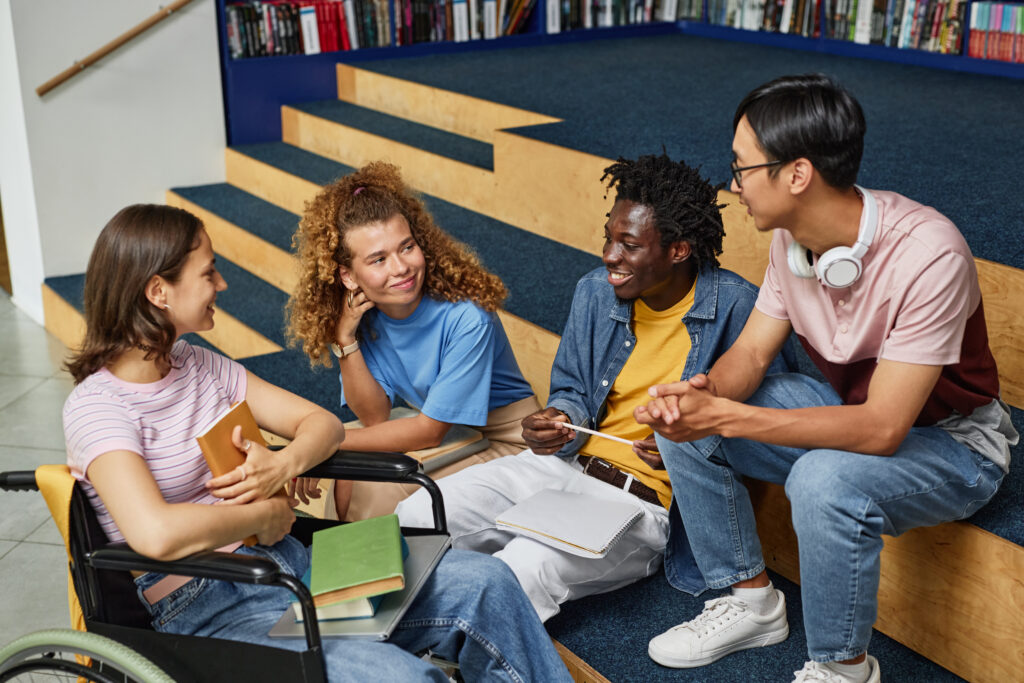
[636,75,1017,683]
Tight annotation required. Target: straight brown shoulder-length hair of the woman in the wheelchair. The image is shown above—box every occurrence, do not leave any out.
[67,204,203,384]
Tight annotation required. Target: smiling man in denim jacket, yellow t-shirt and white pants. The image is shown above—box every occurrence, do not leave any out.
[397,155,790,620]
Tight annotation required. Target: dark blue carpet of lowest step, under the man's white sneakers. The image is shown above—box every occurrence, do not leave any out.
[547,570,963,683]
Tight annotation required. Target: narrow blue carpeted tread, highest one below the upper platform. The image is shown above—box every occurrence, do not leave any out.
[289,99,495,171]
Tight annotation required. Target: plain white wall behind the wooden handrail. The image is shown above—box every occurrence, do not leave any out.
[0,0,225,321]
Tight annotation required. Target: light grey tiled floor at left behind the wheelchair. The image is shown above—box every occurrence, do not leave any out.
[0,291,72,645]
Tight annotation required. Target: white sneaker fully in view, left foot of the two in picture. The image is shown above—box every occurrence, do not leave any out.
[647,589,790,669]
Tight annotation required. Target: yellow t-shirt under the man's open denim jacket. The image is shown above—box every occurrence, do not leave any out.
[580,283,696,507]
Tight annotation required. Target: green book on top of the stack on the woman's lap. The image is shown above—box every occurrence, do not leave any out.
[309,514,406,607]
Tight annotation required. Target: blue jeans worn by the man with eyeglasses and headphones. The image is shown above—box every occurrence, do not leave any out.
[656,374,1004,661]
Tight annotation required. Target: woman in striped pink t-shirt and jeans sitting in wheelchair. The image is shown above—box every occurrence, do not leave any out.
[63,205,568,681]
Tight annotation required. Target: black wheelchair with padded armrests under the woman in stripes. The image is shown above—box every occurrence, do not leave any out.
[0,451,447,683]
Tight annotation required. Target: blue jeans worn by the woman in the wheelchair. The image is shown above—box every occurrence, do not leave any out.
[135,537,571,683]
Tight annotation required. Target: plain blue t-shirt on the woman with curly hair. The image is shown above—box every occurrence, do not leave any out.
[339,296,534,426]
